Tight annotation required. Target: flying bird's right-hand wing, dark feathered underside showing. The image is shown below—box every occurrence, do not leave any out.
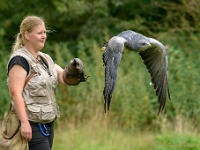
[139,38,170,114]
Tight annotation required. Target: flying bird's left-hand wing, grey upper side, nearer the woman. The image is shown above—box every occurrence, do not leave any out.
[103,36,125,113]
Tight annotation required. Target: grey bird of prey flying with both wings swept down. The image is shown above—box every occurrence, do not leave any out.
[102,30,170,114]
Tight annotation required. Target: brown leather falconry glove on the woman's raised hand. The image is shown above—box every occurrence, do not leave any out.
[63,58,88,85]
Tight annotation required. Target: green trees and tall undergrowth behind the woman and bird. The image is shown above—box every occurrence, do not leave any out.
[0,0,200,131]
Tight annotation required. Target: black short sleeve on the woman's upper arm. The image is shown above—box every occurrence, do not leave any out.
[8,56,29,74]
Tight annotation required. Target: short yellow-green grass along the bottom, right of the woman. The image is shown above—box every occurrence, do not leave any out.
[53,118,200,150]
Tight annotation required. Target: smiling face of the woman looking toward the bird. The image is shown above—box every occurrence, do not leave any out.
[25,23,47,51]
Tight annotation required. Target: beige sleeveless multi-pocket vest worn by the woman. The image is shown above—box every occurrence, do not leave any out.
[8,47,60,123]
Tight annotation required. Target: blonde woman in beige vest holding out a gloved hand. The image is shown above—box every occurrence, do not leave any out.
[7,16,84,150]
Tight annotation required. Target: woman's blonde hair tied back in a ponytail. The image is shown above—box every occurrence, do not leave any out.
[13,16,45,51]
